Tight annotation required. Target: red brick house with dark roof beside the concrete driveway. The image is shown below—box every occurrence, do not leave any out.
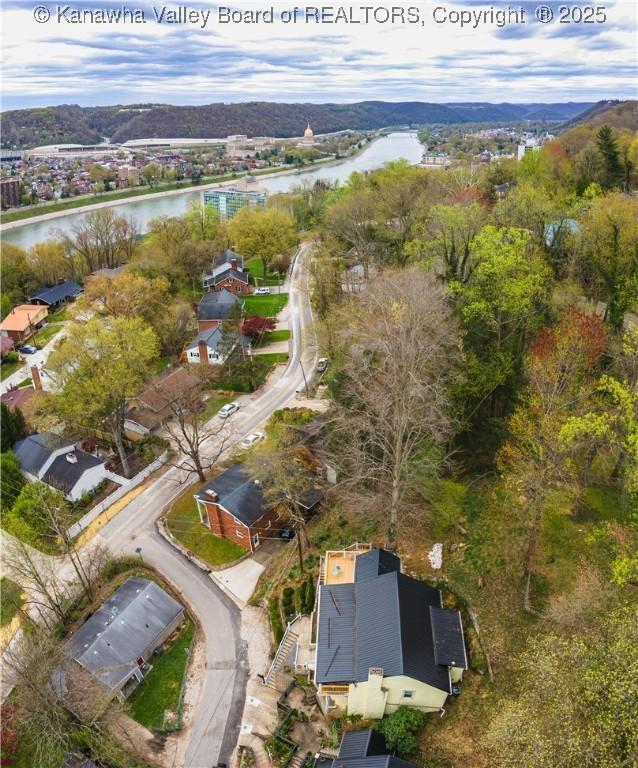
[195,464,323,552]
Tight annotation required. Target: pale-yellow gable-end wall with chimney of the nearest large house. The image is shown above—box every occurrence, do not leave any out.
[348,675,447,718]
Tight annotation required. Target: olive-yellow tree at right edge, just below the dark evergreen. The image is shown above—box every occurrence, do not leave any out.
[582,193,638,329]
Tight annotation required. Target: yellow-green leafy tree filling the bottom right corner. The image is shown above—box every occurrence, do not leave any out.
[484,605,638,768]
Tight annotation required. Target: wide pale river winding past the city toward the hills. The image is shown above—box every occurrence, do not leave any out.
[2,132,423,248]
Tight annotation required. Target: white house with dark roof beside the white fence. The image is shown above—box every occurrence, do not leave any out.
[13,432,115,501]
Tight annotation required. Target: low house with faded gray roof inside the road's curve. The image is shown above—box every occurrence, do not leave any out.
[52,577,184,700]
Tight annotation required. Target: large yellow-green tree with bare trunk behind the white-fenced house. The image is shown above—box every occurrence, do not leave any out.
[48,317,158,477]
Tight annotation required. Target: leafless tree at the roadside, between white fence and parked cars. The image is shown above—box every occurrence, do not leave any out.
[162,387,231,483]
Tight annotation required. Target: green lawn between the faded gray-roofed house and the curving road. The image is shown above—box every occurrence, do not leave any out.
[129,619,195,728]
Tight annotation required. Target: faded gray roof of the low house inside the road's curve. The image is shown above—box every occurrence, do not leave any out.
[65,578,184,690]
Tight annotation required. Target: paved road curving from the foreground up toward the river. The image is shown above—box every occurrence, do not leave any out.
[92,245,317,768]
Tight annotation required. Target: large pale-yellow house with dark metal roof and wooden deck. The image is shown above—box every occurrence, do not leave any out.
[311,548,468,719]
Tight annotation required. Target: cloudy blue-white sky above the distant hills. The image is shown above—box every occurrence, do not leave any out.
[1,0,638,109]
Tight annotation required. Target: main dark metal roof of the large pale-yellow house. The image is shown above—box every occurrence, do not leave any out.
[315,556,458,693]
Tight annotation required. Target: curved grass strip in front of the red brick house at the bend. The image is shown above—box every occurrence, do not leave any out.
[167,485,246,565]
